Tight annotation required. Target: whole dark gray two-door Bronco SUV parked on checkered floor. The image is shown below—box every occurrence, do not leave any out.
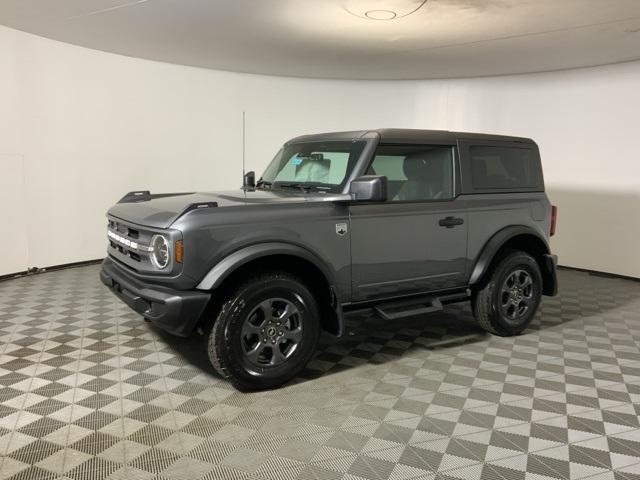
[100,129,557,389]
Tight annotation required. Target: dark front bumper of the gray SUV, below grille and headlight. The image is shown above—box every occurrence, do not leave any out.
[100,258,211,337]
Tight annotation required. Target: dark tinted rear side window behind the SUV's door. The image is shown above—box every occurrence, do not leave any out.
[469,145,542,191]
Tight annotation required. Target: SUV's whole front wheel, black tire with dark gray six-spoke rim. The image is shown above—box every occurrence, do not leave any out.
[207,272,320,389]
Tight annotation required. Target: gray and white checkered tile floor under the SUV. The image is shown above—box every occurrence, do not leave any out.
[0,266,640,480]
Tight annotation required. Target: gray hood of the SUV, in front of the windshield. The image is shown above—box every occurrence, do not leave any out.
[108,189,343,228]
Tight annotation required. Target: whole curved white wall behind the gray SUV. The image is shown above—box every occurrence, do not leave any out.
[0,27,640,277]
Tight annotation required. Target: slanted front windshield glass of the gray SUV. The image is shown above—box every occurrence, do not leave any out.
[257,142,365,192]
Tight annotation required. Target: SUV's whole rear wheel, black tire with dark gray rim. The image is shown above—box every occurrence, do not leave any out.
[471,251,542,337]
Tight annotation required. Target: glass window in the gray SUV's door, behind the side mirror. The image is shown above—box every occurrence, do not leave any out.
[367,145,453,202]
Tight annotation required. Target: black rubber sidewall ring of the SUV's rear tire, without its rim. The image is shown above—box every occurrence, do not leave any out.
[491,253,542,334]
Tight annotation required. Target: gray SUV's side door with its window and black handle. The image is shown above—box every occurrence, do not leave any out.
[350,145,467,301]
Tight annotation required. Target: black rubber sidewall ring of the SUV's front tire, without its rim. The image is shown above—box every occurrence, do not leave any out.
[214,278,320,388]
